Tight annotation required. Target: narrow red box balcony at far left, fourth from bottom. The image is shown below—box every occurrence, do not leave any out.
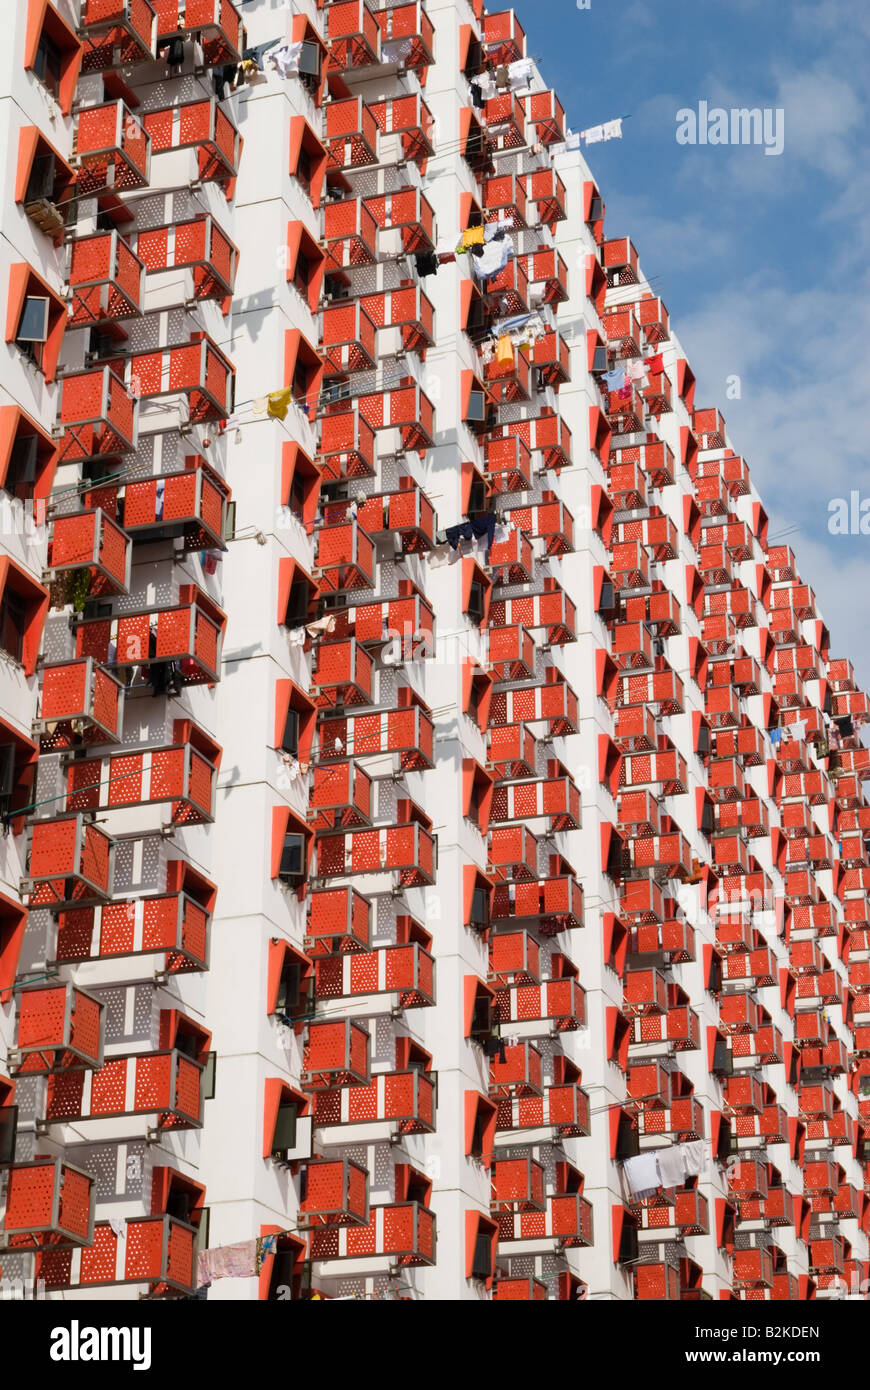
[38,656,124,752]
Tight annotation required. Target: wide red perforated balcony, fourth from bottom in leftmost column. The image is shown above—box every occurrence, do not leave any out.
[65,742,217,826]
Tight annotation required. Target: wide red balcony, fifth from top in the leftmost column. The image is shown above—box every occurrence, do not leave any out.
[121,467,229,550]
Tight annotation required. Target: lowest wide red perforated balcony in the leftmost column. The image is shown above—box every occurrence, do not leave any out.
[39,1216,196,1294]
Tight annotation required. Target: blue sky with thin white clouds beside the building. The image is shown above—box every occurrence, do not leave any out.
[513,0,870,688]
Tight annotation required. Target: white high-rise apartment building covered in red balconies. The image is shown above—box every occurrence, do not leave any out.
[0,0,870,1302]
